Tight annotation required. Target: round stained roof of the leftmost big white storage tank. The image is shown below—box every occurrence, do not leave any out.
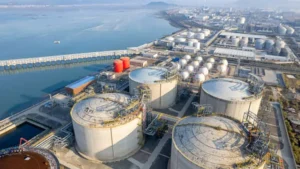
[71,93,131,126]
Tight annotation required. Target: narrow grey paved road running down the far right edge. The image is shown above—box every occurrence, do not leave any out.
[272,102,296,169]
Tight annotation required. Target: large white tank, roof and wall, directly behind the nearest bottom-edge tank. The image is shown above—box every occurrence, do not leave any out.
[200,78,262,121]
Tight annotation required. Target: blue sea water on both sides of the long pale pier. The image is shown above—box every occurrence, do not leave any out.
[0,8,177,120]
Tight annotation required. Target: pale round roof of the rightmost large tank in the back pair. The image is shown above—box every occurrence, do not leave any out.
[202,78,252,101]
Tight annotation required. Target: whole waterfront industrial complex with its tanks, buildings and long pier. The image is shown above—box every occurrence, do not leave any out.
[0,4,300,169]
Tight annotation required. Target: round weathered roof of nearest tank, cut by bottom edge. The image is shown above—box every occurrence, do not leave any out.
[173,116,253,168]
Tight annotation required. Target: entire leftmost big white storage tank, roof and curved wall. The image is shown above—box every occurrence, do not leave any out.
[71,93,143,162]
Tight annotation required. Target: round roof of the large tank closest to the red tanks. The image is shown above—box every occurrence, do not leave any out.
[129,67,168,84]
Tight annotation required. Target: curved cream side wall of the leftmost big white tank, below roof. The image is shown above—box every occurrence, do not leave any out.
[73,117,141,161]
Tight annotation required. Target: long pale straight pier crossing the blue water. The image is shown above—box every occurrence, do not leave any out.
[0,50,140,71]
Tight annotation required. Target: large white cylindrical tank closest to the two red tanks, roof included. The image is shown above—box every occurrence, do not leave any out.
[129,67,178,109]
